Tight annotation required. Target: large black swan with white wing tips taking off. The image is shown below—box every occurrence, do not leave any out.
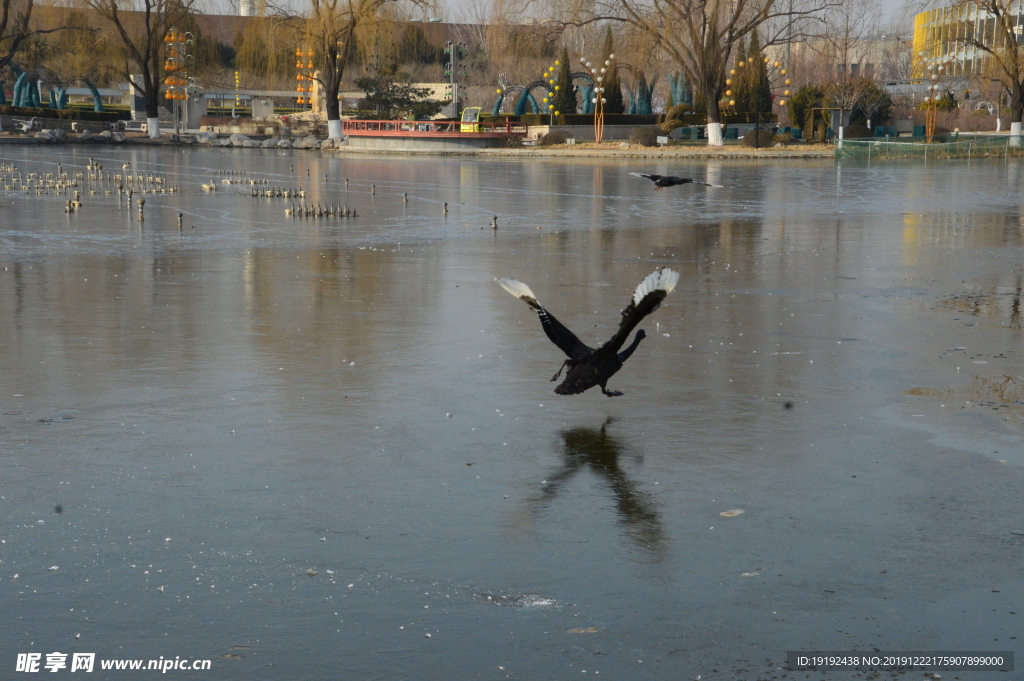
[495,267,679,397]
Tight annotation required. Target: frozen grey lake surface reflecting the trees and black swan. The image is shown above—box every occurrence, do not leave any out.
[0,146,1024,681]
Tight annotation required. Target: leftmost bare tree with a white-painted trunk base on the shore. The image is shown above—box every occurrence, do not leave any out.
[84,0,196,137]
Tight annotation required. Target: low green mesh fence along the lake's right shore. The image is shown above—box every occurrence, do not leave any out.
[836,135,1024,161]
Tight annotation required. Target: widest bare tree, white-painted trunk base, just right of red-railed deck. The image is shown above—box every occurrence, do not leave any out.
[575,0,828,146]
